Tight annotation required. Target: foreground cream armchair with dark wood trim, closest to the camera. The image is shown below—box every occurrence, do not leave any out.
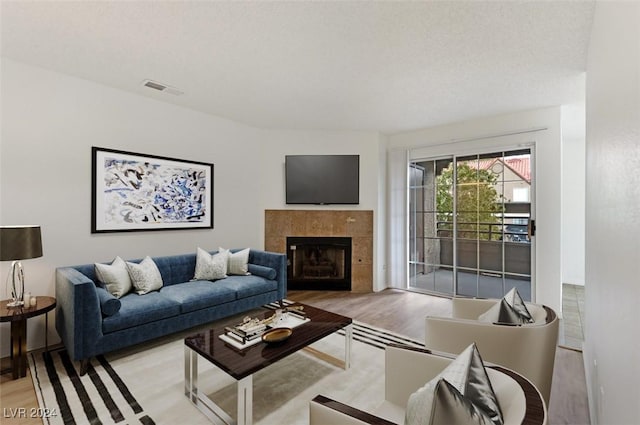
[309,346,547,425]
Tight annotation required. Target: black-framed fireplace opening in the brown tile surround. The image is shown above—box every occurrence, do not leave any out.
[287,237,351,291]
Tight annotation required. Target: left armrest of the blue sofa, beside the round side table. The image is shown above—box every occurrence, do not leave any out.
[56,267,102,360]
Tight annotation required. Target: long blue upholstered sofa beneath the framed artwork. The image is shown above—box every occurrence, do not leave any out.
[56,249,287,374]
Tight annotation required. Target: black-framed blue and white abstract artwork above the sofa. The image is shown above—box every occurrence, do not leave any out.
[91,146,213,233]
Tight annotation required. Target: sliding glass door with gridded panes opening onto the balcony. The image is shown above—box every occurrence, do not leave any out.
[408,149,535,300]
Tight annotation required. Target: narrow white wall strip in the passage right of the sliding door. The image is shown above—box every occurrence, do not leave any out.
[562,103,586,285]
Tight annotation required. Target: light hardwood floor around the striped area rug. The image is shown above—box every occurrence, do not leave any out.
[0,289,589,425]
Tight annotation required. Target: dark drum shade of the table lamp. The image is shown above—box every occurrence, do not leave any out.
[0,226,42,261]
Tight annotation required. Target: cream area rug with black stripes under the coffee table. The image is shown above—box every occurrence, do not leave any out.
[30,306,424,424]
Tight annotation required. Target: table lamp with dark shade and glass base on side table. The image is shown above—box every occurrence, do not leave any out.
[0,226,42,307]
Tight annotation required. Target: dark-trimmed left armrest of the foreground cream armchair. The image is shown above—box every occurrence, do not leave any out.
[309,395,394,425]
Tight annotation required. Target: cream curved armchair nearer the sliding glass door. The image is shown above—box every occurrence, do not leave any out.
[425,298,559,404]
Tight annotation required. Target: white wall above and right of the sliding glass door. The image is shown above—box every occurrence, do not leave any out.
[389,107,562,314]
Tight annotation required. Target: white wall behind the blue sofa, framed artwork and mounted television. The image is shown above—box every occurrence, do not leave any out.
[0,58,385,356]
